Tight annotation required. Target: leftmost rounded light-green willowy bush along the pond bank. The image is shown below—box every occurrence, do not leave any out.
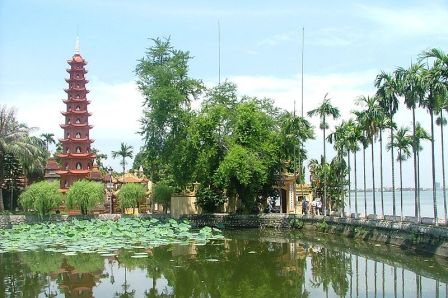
[19,181,63,216]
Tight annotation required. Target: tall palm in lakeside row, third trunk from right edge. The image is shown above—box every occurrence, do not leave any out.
[394,63,424,222]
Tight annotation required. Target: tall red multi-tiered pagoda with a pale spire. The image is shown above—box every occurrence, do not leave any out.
[58,38,95,191]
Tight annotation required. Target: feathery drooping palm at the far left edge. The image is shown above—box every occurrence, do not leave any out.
[0,106,42,211]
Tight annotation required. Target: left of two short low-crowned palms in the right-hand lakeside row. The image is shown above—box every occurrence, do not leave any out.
[387,127,412,220]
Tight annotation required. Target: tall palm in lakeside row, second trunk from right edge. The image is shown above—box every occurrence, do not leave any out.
[422,62,447,225]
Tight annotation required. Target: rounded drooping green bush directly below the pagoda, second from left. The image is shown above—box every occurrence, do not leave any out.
[66,180,104,215]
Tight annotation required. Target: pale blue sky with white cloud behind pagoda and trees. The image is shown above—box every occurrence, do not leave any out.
[0,0,448,187]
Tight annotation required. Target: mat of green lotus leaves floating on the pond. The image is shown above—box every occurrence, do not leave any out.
[0,218,224,254]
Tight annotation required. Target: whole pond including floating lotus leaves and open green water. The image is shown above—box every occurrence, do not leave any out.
[0,219,448,297]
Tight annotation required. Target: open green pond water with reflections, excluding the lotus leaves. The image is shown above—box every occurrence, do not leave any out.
[0,231,448,297]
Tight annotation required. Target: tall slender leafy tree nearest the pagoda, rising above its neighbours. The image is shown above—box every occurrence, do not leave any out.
[136,38,204,182]
